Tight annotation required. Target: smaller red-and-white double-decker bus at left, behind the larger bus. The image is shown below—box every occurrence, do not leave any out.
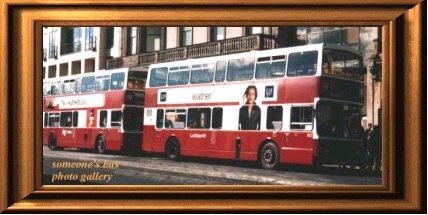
[43,68,147,153]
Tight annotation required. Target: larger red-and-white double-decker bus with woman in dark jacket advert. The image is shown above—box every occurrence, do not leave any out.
[142,44,364,169]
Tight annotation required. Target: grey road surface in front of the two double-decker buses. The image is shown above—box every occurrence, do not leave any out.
[43,146,382,186]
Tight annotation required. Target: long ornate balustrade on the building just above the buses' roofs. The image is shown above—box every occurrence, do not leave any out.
[107,34,277,69]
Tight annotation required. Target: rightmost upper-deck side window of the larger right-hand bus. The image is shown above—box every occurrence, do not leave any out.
[287,51,318,76]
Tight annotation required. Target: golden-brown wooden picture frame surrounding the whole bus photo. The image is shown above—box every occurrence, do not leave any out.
[0,0,426,212]
